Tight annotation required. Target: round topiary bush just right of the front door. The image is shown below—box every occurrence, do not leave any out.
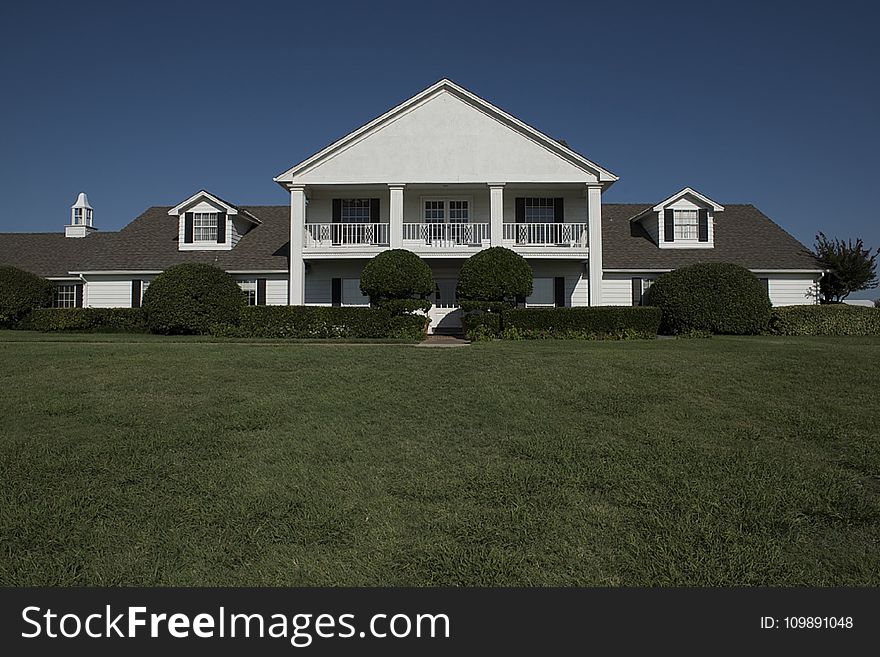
[456,246,533,309]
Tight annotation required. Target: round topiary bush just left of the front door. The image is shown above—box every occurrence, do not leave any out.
[361,249,434,315]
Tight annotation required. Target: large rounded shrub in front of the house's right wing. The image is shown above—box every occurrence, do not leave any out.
[648,262,770,335]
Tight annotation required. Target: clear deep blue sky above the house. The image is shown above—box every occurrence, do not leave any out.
[0,0,880,255]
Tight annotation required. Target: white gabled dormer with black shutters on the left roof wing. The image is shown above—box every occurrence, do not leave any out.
[168,190,260,251]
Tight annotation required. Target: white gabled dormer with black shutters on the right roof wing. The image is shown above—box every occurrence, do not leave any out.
[632,187,724,249]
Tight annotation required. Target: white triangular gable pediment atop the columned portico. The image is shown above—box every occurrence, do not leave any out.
[275,80,617,185]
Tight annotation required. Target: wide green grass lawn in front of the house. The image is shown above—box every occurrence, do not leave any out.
[0,333,880,586]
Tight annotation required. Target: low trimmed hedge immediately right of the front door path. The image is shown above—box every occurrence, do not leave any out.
[463,306,661,340]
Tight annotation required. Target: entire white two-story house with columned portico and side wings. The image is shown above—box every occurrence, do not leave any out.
[0,80,822,330]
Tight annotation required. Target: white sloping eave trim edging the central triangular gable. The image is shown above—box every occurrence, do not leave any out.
[273,78,618,189]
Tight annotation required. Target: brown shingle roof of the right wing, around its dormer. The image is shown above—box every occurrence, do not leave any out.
[602,203,820,271]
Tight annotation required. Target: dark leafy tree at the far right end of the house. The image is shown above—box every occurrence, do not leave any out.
[813,232,880,303]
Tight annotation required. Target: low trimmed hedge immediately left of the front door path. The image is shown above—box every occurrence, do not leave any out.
[214,306,427,341]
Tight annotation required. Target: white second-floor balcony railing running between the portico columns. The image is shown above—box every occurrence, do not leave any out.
[303,222,588,255]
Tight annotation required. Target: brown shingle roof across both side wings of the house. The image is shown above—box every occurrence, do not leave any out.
[0,203,818,277]
